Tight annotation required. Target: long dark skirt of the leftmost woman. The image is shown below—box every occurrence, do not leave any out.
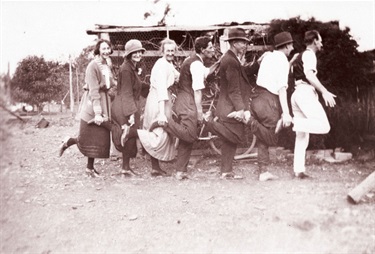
[77,120,111,158]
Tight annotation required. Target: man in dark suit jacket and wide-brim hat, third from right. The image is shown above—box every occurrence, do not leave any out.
[208,27,250,179]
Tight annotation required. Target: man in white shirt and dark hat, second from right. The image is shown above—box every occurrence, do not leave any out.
[229,32,293,181]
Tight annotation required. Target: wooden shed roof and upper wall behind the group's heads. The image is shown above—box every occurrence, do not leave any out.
[86,22,271,72]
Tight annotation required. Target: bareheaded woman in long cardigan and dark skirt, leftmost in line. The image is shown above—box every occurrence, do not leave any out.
[60,39,123,177]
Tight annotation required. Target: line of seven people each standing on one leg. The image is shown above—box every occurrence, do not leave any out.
[60,28,335,181]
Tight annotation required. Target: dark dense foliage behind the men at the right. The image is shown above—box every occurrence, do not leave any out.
[268,17,375,149]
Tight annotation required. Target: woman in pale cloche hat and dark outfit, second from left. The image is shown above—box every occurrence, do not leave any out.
[112,39,146,177]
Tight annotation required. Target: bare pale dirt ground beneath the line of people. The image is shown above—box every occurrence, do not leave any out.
[0,115,375,254]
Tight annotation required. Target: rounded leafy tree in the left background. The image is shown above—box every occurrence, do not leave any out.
[11,56,66,110]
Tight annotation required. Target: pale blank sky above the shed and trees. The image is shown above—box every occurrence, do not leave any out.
[0,0,375,74]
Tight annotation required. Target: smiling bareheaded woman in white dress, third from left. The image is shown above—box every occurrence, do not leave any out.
[138,39,180,176]
